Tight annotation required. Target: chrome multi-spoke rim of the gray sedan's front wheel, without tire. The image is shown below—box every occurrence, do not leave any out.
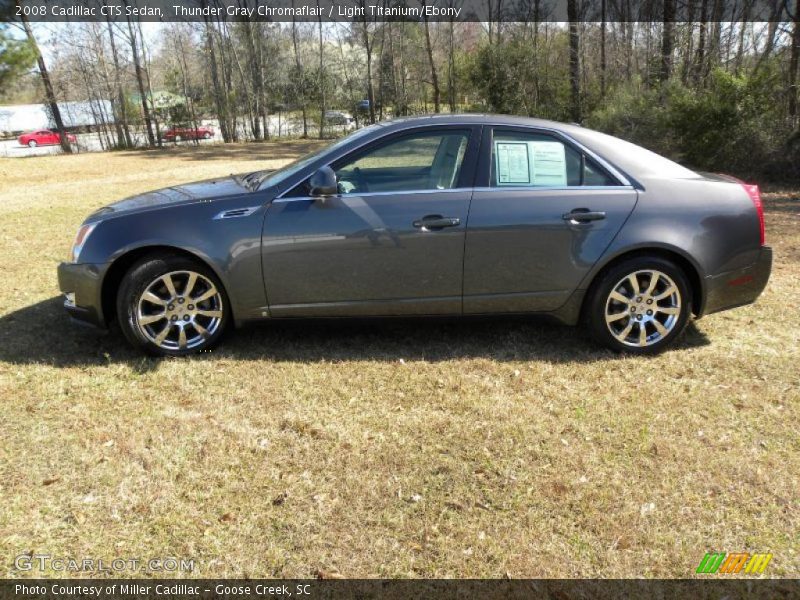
[136,271,224,350]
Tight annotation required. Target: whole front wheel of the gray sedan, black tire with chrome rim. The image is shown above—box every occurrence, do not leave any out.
[117,254,231,356]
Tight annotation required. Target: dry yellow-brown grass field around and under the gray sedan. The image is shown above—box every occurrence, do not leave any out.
[0,143,800,577]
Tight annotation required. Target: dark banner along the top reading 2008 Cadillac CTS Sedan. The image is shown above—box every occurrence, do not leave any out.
[0,0,800,22]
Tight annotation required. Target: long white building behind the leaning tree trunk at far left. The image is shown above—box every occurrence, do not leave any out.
[0,100,114,135]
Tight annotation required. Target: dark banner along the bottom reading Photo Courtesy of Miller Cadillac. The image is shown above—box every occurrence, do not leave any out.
[0,578,800,600]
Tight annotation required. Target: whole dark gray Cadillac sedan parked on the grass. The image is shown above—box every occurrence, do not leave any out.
[58,115,772,355]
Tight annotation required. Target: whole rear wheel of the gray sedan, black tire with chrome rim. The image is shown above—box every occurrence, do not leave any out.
[585,256,692,355]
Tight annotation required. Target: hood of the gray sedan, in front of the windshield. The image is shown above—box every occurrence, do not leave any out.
[89,175,250,220]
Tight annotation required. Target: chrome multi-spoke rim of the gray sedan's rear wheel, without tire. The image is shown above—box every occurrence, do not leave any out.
[605,269,681,347]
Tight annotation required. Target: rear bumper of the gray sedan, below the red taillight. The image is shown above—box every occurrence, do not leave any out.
[698,246,772,316]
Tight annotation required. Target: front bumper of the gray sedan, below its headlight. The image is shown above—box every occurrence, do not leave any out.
[58,263,106,329]
